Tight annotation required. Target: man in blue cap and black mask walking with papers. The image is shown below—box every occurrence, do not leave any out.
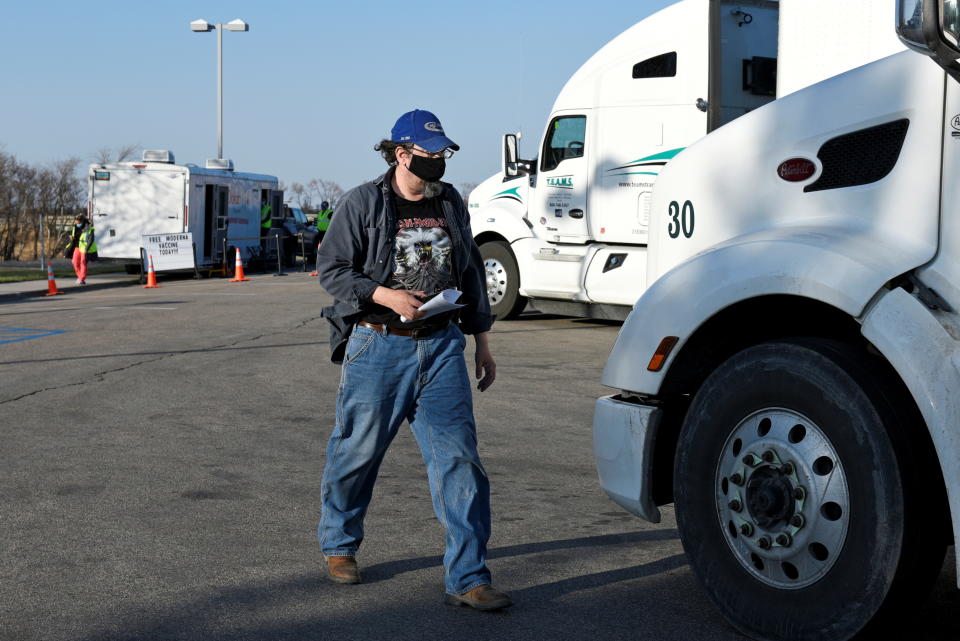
[317,109,511,610]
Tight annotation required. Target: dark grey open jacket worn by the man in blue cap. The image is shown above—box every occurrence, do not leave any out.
[317,168,493,363]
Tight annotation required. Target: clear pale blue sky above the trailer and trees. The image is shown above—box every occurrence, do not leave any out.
[0,0,671,189]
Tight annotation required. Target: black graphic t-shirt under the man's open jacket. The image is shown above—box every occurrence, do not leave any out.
[364,194,457,329]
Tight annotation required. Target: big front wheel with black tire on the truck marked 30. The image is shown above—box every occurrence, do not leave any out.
[674,339,946,641]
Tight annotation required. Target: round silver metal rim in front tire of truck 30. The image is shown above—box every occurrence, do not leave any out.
[715,408,850,589]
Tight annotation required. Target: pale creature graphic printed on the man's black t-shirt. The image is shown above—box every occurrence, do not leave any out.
[393,218,454,295]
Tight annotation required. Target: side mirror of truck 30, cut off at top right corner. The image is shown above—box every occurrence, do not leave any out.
[897,0,960,75]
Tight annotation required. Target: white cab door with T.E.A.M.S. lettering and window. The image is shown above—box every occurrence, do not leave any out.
[531,110,590,244]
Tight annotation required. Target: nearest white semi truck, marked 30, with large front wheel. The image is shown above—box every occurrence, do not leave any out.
[593,0,960,641]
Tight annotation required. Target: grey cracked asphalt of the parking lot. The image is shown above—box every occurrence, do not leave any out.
[0,274,960,641]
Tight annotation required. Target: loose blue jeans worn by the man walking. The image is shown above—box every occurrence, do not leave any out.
[317,325,490,594]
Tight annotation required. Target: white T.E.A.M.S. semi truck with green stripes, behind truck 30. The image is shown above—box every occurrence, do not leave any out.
[469,0,902,320]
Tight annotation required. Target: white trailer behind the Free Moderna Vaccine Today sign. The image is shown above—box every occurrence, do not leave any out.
[88,150,283,271]
